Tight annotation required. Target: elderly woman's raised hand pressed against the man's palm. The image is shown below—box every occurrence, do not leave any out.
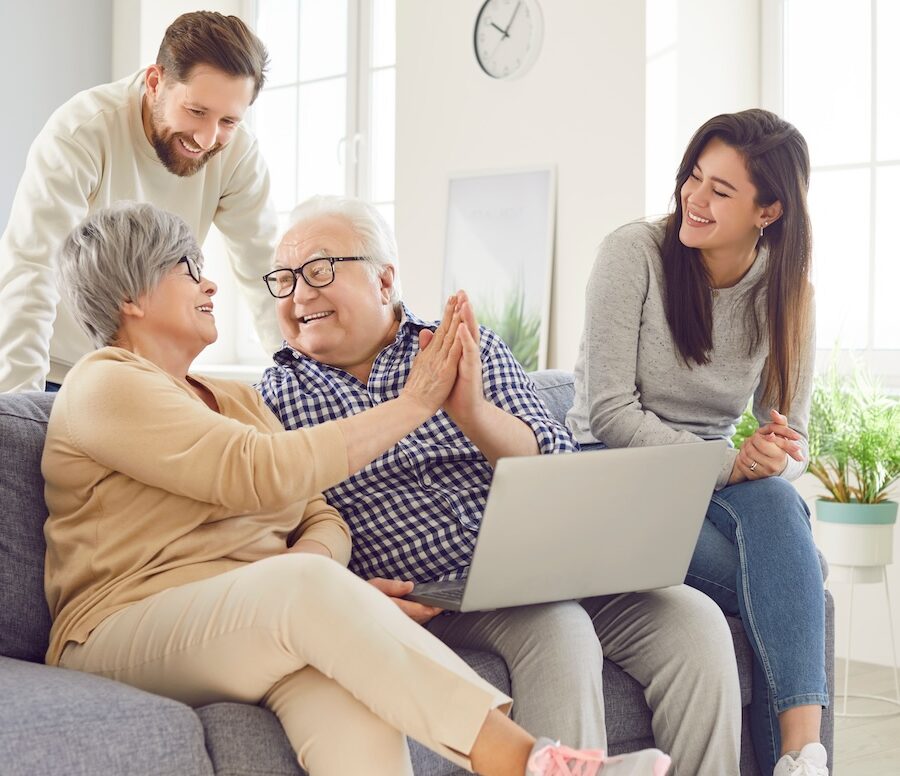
[400,294,462,418]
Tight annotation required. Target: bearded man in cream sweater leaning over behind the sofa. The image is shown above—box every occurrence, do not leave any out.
[0,11,280,392]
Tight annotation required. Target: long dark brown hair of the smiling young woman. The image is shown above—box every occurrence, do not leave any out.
[662,109,812,414]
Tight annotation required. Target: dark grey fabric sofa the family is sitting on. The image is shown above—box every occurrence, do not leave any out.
[0,371,834,776]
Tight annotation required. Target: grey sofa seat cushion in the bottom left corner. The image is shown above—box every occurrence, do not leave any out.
[0,657,213,776]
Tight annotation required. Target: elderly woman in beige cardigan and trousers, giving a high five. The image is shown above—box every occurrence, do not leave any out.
[42,203,668,776]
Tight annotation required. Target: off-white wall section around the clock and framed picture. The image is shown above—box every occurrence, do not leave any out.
[396,0,644,368]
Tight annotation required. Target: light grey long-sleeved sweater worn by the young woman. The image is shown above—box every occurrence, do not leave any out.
[567,221,815,488]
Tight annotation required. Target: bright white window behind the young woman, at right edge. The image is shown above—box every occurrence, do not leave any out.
[764,0,900,389]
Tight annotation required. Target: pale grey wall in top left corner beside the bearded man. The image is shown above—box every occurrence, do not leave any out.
[0,0,112,232]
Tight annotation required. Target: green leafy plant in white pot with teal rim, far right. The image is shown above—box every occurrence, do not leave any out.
[809,364,900,582]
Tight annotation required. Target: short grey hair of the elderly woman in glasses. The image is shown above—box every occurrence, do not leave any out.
[57,202,203,348]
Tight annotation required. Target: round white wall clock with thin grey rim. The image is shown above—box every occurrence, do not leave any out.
[475,0,544,78]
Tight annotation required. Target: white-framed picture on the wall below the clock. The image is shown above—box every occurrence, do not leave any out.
[442,166,556,372]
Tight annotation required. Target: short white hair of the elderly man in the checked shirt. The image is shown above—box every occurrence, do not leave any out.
[288,194,400,306]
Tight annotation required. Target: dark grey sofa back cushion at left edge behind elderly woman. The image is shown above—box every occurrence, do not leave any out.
[0,393,55,662]
